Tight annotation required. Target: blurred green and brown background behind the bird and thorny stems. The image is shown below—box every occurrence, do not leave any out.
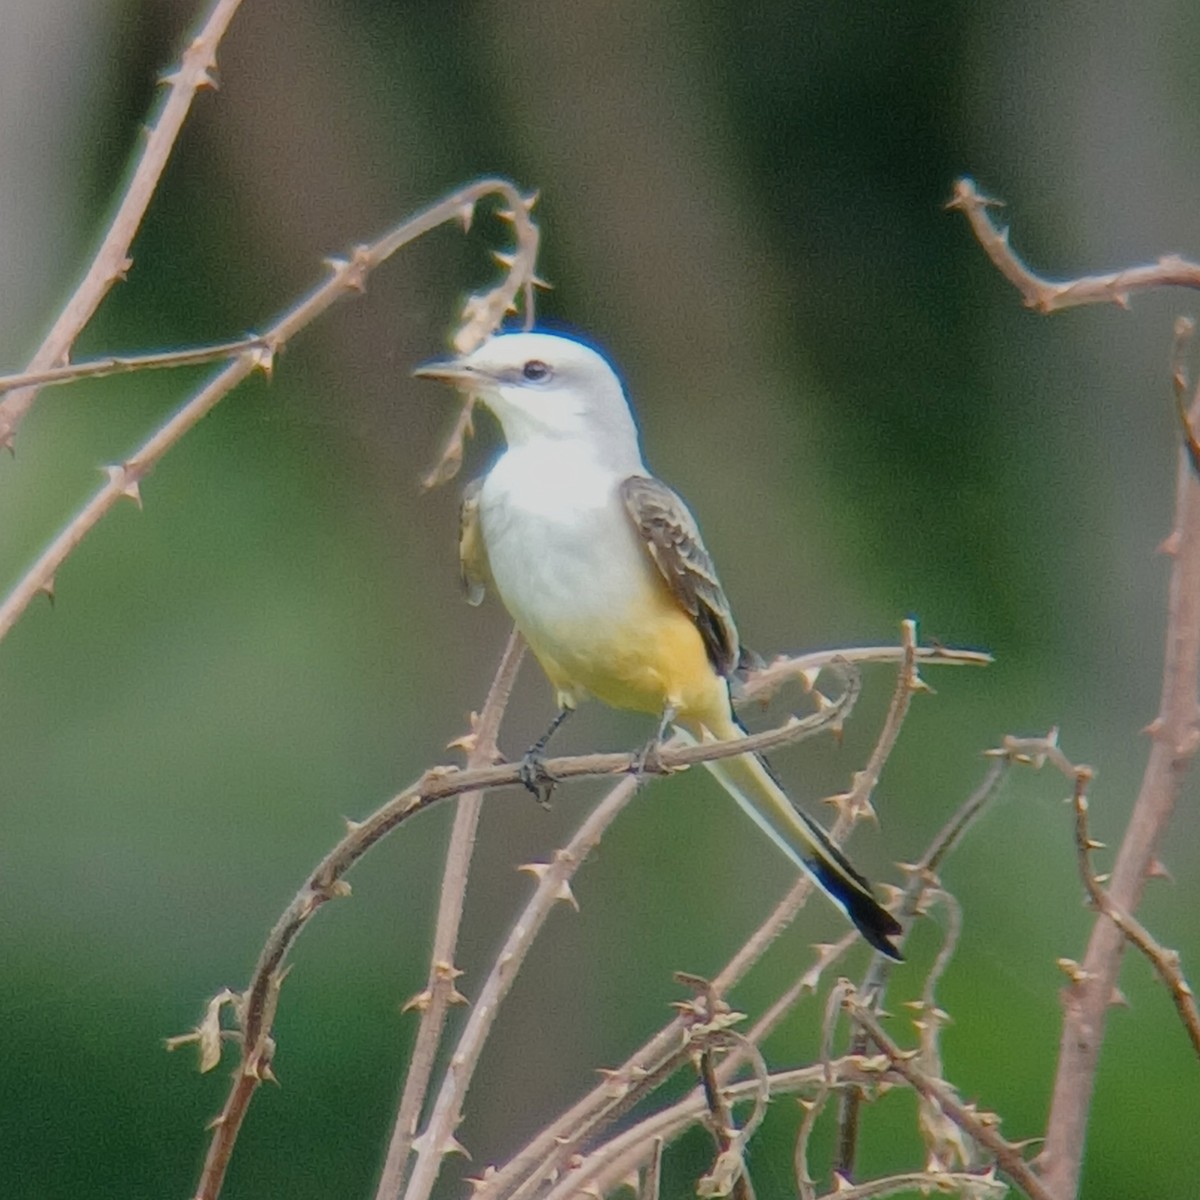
[0,0,1200,1200]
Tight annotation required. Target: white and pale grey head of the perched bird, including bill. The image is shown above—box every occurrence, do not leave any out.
[414,334,641,470]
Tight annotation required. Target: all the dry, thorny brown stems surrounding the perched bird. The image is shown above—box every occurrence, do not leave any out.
[0,0,1200,1200]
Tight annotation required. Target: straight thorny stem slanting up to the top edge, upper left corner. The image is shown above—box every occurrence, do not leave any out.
[0,0,241,449]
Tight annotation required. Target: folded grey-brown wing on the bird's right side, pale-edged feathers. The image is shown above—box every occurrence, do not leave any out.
[620,475,739,677]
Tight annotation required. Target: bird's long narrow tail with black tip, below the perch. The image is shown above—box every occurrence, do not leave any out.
[704,721,902,960]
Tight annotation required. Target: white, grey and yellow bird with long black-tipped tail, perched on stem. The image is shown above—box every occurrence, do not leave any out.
[416,334,900,958]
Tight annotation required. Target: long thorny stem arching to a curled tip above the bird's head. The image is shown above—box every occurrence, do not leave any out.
[0,177,538,638]
